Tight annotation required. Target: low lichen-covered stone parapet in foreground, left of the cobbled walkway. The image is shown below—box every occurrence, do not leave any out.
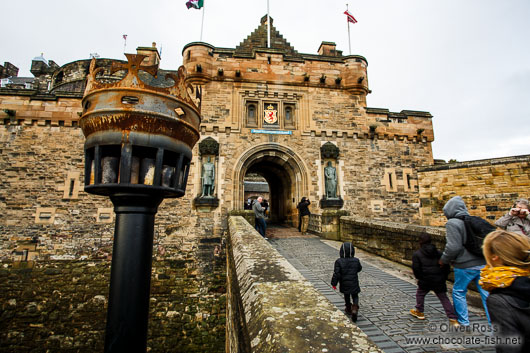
[227,216,380,353]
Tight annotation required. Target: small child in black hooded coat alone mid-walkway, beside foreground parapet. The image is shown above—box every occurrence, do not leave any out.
[331,242,363,322]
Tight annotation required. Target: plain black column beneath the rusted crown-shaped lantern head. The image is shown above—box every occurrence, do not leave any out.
[105,193,163,353]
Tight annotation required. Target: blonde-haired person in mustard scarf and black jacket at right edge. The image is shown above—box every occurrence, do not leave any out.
[480,230,530,352]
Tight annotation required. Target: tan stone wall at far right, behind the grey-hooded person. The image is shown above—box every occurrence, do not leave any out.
[418,155,530,226]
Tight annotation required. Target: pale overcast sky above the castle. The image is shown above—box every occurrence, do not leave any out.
[0,0,530,161]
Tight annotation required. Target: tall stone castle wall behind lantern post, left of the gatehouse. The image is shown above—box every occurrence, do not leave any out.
[0,92,226,352]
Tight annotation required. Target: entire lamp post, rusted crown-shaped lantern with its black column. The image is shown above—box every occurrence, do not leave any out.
[80,54,200,352]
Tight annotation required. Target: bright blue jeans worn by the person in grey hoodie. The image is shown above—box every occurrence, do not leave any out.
[453,266,491,326]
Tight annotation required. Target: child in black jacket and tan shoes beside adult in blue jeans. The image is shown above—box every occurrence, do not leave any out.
[410,233,459,327]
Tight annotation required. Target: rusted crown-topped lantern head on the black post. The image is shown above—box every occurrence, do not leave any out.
[80,54,200,198]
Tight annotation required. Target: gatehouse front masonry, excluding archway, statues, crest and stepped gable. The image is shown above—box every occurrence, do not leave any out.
[183,43,433,224]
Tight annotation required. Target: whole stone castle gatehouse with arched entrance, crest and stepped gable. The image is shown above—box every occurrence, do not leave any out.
[182,16,432,223]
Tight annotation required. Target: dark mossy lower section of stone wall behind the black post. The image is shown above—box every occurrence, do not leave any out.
[0,256,226,353]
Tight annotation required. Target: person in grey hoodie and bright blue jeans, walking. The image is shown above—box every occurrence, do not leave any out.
[440,196,490,326]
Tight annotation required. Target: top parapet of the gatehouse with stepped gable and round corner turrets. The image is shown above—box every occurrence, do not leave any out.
[182,19,370,102]
